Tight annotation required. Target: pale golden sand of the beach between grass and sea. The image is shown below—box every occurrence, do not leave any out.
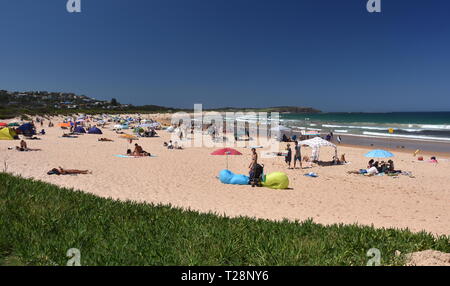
[0,116,450,235]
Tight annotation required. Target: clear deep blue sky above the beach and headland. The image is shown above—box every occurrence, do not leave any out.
[0,0,450,112]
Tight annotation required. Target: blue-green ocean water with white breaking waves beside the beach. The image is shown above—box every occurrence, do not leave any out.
[280,112,450,142]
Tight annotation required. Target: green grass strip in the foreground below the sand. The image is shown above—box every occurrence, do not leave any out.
[0,173,450,265]
